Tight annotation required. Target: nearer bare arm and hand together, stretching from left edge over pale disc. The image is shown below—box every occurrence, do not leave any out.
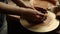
[0,2,44,20]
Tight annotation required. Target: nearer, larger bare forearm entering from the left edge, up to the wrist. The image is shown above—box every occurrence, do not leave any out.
[0,2,30,15]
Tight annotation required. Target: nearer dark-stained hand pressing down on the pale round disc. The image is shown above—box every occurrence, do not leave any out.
[21,10,46,24]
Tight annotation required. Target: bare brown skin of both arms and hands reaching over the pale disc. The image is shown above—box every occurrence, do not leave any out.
[0,0,56,20]
